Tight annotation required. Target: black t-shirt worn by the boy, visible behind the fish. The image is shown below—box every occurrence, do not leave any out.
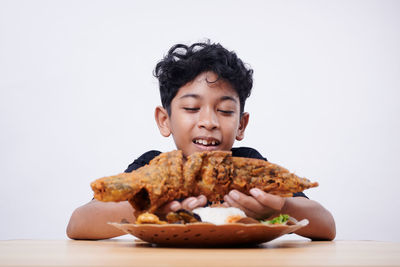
[125,147,307,198]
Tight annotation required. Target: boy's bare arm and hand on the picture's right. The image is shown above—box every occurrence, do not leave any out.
[224,189,336,240]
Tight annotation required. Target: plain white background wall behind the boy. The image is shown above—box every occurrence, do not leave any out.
[0,0,400,241]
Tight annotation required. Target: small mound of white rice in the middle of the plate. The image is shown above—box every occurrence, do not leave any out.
[192,207,246,225]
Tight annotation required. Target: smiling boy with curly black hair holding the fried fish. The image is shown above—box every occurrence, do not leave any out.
[67,42,336,240]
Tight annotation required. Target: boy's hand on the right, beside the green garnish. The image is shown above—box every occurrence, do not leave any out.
[223,188,285,219]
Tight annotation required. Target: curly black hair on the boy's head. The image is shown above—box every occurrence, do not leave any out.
[154,40,253,115]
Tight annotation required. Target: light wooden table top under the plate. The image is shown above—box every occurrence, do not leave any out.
[0,239,400,267]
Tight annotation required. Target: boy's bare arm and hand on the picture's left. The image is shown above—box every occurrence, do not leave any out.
[67,195,207,242]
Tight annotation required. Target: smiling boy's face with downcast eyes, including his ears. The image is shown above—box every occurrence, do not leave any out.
[155,72,249,156]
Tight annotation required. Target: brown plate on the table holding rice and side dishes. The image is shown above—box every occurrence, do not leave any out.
[109,219,308,246]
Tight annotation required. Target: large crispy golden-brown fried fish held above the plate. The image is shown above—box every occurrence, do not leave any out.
[91,150,318,216]
